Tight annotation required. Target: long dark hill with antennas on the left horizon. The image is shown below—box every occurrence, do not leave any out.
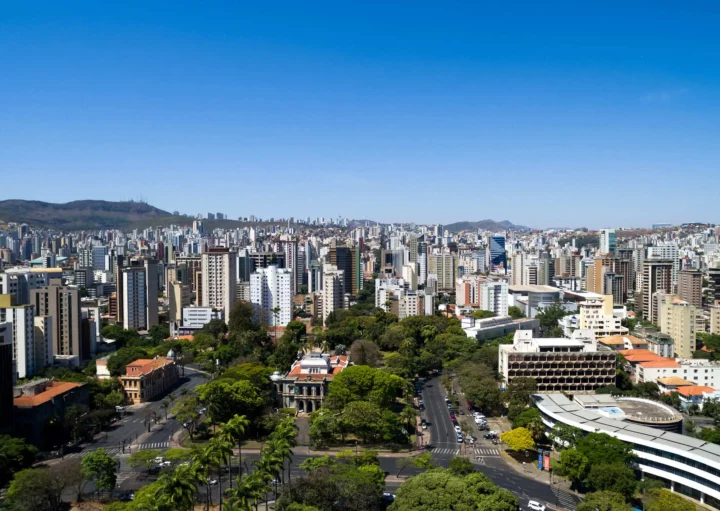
[0,199,175,231]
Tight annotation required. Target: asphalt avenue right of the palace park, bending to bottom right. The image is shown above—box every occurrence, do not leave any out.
[422,377,578,511]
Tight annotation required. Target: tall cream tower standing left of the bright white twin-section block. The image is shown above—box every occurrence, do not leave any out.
[200,248,238,321]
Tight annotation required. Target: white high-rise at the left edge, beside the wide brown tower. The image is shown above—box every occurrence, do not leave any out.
[0,295,35,378]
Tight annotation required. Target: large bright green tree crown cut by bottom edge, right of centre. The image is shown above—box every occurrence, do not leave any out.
[389,468,519,511]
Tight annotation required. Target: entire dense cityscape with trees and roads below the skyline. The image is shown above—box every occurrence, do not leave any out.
[0,212,720,511]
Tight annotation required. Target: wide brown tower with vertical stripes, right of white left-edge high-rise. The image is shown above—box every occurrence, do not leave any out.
[31,279,81,360]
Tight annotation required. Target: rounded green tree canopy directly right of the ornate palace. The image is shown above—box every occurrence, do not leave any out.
[327,366,404,410]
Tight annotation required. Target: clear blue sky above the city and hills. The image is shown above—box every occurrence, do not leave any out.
[0,0,720,227]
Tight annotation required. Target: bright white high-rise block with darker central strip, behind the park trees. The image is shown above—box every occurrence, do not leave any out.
[250,265,293,326]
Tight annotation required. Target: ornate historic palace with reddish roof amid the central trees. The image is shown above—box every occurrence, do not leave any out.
[275,353,348,413]
